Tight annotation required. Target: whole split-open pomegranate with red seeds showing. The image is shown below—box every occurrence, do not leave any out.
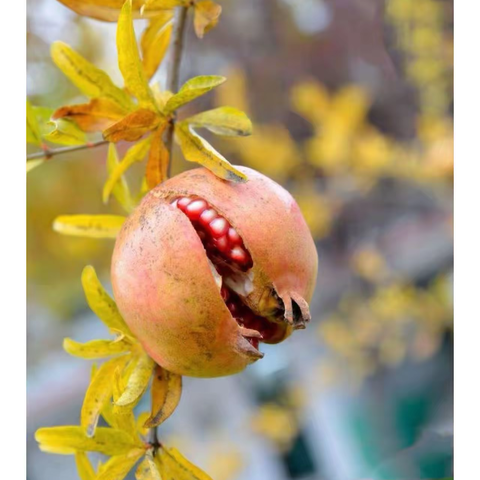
[112,167,318,377]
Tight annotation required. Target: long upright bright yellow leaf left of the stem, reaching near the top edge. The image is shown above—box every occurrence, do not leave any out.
[117,0,157,110]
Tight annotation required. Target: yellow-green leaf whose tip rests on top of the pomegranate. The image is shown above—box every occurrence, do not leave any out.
[175,122,247,182]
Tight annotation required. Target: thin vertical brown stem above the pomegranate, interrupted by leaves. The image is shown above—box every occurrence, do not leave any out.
[165,7,188,176]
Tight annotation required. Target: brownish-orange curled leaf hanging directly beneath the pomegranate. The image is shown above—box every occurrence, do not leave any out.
[145,365,182,428]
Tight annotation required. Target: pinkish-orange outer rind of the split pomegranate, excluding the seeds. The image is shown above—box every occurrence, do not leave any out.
[112,167,318,377]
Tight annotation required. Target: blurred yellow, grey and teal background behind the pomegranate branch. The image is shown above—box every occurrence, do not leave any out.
[27,0,453,480]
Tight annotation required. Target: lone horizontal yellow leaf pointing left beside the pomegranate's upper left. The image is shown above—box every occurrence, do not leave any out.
[53,215,125,238]
